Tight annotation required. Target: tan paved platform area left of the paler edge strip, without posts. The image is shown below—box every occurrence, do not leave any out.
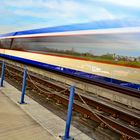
[0,92,55,140]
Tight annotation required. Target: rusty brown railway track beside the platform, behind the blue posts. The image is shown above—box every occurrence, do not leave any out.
[1,65,140,140]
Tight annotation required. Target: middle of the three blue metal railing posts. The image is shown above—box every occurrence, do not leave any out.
[20,67,27,104]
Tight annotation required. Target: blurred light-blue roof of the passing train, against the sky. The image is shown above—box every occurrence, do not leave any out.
[0,20,140,38]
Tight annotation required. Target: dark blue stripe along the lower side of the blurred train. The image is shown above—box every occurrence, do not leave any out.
[0,54,140,90]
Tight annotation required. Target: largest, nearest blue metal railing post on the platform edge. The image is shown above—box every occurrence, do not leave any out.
[62,86,75,140]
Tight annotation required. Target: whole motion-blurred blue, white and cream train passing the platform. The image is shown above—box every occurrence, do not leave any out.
[0,21,140,91]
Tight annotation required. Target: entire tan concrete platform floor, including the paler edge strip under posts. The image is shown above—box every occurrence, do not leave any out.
[0,81,92,140]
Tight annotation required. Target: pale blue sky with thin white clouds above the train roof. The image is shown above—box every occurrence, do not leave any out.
[0,0,140,34]
